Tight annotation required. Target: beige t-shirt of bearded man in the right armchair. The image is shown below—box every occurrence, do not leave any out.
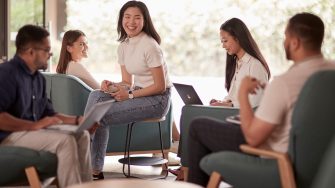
[255,56,335,152]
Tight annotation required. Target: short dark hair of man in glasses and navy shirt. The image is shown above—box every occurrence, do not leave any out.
[15,25,50,53]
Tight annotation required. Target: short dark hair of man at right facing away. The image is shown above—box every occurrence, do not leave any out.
[287,12,325,50]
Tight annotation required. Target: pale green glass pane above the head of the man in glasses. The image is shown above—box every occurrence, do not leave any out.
[8,0,43,58]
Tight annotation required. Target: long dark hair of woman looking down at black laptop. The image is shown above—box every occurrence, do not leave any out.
[220,18,271,91]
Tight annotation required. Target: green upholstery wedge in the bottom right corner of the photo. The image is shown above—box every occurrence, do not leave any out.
[312,137,335,188]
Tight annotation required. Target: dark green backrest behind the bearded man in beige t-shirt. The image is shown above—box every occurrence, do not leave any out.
[289,70,335,187]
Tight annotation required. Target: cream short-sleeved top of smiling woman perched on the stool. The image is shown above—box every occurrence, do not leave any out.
[118,32,172,88]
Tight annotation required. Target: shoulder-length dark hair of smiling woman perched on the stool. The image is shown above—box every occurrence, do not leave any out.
[117,1,161,44]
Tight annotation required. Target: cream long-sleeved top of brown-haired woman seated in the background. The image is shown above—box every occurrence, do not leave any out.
[66,61,100,89]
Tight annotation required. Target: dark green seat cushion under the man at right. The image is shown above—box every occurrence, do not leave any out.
[200,151,281,188]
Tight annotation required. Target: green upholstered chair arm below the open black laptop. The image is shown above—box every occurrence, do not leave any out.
[179,105,239,167]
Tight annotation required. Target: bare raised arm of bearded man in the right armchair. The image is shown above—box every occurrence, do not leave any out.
[238,77,275,147]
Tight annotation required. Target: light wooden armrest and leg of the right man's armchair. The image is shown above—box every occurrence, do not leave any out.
[240,144,296,188]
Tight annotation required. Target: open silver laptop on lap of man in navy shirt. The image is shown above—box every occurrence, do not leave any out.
[46,100,115,134]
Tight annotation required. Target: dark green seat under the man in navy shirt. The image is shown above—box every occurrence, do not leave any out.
[0,146,57,186]
